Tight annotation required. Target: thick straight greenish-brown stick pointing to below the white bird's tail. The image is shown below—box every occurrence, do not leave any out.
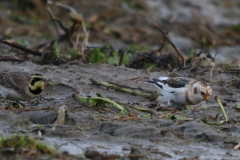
[90,78,158,99]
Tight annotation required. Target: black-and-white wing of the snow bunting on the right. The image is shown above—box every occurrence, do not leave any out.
[148,77,192,93]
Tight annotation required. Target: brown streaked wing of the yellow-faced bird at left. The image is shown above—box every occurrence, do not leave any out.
[0,72,29,90]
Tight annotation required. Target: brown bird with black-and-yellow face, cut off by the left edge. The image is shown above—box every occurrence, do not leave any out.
[0,72,45,101]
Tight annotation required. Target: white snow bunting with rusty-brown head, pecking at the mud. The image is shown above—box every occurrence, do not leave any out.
[147,77,212,105]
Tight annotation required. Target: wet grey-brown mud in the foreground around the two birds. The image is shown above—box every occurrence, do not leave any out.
[1,62,240,159]
